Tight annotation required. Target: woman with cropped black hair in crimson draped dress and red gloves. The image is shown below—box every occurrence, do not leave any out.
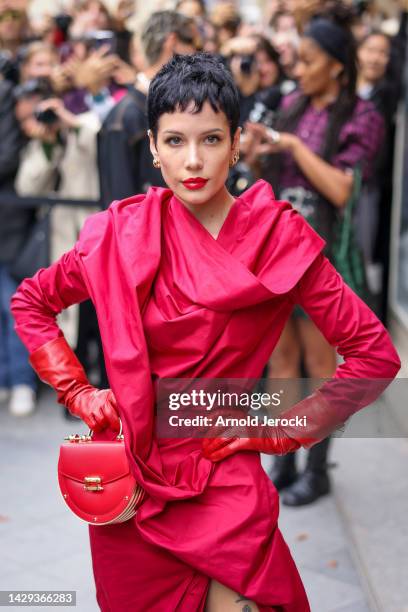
[12,54,399,612]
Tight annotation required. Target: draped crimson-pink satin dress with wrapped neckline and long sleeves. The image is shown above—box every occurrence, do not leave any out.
[13,181,399,612]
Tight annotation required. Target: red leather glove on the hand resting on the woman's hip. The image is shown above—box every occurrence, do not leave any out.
[202,391,342,461]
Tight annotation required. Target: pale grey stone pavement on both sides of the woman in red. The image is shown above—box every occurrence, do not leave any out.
[0,390,408,612]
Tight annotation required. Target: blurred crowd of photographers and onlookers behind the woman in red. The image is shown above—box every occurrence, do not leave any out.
[0,0,408,505]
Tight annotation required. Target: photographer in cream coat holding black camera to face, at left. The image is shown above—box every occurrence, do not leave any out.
[15,81,100,358]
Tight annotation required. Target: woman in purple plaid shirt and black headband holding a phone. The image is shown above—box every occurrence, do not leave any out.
[246,4,384,506]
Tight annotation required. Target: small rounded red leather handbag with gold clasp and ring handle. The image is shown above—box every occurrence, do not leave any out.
[58,424,145,525]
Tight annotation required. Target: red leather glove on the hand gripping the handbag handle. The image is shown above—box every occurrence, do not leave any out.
[30,337,120,432]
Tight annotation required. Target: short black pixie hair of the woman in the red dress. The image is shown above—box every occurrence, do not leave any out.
[147,53,239,139]
